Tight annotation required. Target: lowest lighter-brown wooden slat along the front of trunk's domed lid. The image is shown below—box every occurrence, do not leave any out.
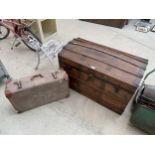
[60,49,141,90]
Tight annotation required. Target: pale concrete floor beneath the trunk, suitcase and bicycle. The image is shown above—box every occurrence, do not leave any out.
[0,20,155,134]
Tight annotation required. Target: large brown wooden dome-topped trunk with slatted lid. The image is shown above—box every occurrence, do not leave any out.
[59,38,148,114]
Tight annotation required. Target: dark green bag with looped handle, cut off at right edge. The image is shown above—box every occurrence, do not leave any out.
[130,69,155,134]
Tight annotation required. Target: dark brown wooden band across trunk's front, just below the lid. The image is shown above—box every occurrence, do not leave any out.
[61,63,132,102]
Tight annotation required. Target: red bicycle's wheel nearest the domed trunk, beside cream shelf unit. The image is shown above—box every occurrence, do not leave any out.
[21,28,41,52]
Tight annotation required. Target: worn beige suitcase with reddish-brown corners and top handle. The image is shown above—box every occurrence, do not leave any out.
[5,70,69,112]
